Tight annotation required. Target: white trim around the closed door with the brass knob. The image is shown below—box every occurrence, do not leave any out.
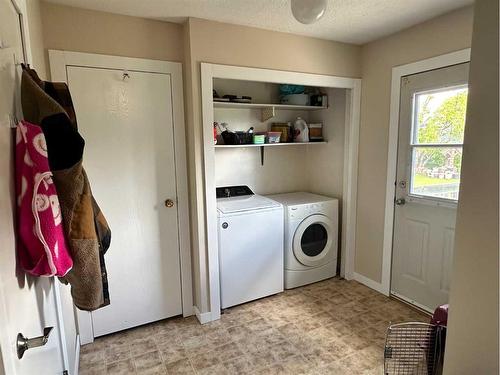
[49,50,193,345]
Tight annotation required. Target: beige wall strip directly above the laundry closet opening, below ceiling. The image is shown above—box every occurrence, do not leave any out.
[189,18,361,77]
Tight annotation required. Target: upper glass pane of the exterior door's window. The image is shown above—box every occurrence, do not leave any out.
[413,87,468,144]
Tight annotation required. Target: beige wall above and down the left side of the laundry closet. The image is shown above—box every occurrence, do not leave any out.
[185,18,361,312]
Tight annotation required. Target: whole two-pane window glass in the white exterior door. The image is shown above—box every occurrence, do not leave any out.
[409,85,468,201]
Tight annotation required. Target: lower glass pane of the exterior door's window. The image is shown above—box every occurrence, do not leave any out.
[410,147,462,200]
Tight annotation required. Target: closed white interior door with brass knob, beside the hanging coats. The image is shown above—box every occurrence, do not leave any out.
[67,66,182,337]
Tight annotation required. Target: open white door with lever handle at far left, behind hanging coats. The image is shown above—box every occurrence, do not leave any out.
[0,0,69,375]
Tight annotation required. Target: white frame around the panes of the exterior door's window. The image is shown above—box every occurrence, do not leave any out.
[406,83,469,208]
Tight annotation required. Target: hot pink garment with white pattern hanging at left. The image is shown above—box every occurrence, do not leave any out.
[16,121,73,276]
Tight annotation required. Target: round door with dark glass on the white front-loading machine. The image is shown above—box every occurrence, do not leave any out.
[293,214,336,267]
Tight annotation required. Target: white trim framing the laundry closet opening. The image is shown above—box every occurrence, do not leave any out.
[201,62,361,321]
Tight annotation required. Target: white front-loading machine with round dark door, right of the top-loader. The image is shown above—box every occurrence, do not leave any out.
[269,192,339,289]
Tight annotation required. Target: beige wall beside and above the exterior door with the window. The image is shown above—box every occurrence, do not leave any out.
[355,7,473,282]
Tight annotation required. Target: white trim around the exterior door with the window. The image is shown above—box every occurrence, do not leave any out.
[379,48,471,296]
